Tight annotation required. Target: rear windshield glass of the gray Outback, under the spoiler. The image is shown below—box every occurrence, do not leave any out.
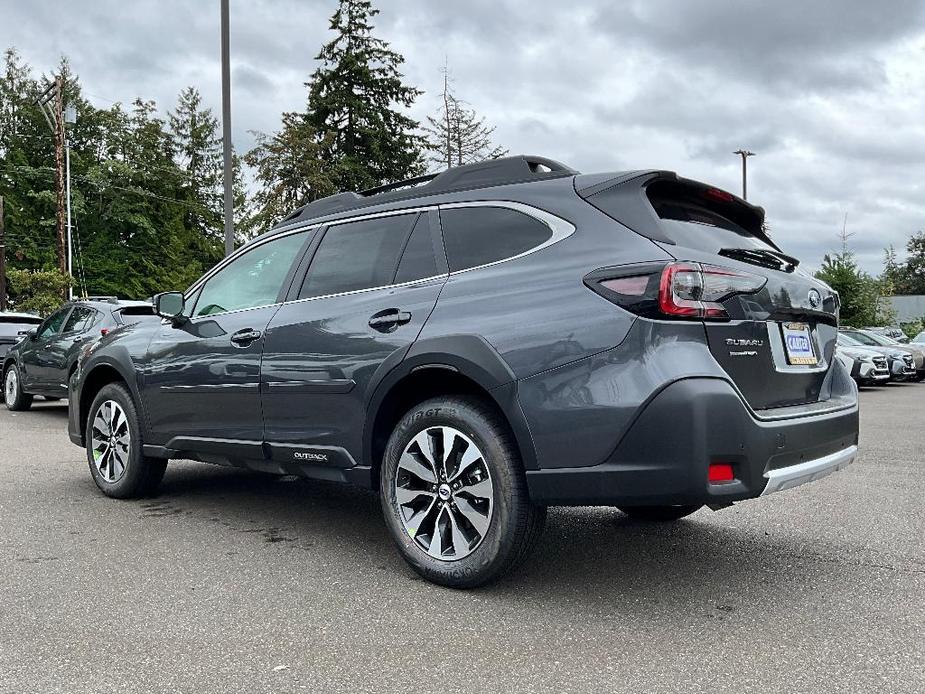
[646,181,775,253]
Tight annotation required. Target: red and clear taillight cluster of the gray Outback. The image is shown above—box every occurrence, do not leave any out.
[585,263,767,320]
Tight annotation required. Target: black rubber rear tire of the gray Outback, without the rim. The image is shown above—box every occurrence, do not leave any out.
[379,396,546,588]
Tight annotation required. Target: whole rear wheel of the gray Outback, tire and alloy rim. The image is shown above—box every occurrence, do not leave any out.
[380,397,546,588]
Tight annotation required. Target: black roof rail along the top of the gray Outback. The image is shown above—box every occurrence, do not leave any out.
[276,155,578,227]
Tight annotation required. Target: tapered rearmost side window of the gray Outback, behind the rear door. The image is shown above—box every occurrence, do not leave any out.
[440,206,552,272]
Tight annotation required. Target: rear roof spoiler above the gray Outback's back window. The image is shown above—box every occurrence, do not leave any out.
[575,170,780,251]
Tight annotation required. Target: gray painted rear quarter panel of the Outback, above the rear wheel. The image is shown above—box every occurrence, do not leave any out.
[420,179,670,379]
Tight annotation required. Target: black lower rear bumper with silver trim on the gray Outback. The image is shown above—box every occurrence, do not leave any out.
[527,378,858,506]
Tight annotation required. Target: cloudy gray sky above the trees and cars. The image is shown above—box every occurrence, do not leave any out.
[0,0,925,272]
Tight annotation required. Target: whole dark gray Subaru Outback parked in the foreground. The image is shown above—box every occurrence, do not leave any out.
[69,156,858,587]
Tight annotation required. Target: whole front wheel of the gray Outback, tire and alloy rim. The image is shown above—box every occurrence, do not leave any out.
[86,383,167,499]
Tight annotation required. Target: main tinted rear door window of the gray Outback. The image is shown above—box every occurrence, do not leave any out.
[299,213,418,299]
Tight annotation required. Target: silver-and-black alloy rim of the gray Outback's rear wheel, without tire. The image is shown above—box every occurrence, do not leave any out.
[395,426,494,561]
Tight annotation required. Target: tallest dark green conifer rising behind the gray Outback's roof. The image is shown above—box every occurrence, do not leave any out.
[306,0,423,190]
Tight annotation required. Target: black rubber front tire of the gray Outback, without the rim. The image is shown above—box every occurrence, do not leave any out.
[86,383,167,499]
